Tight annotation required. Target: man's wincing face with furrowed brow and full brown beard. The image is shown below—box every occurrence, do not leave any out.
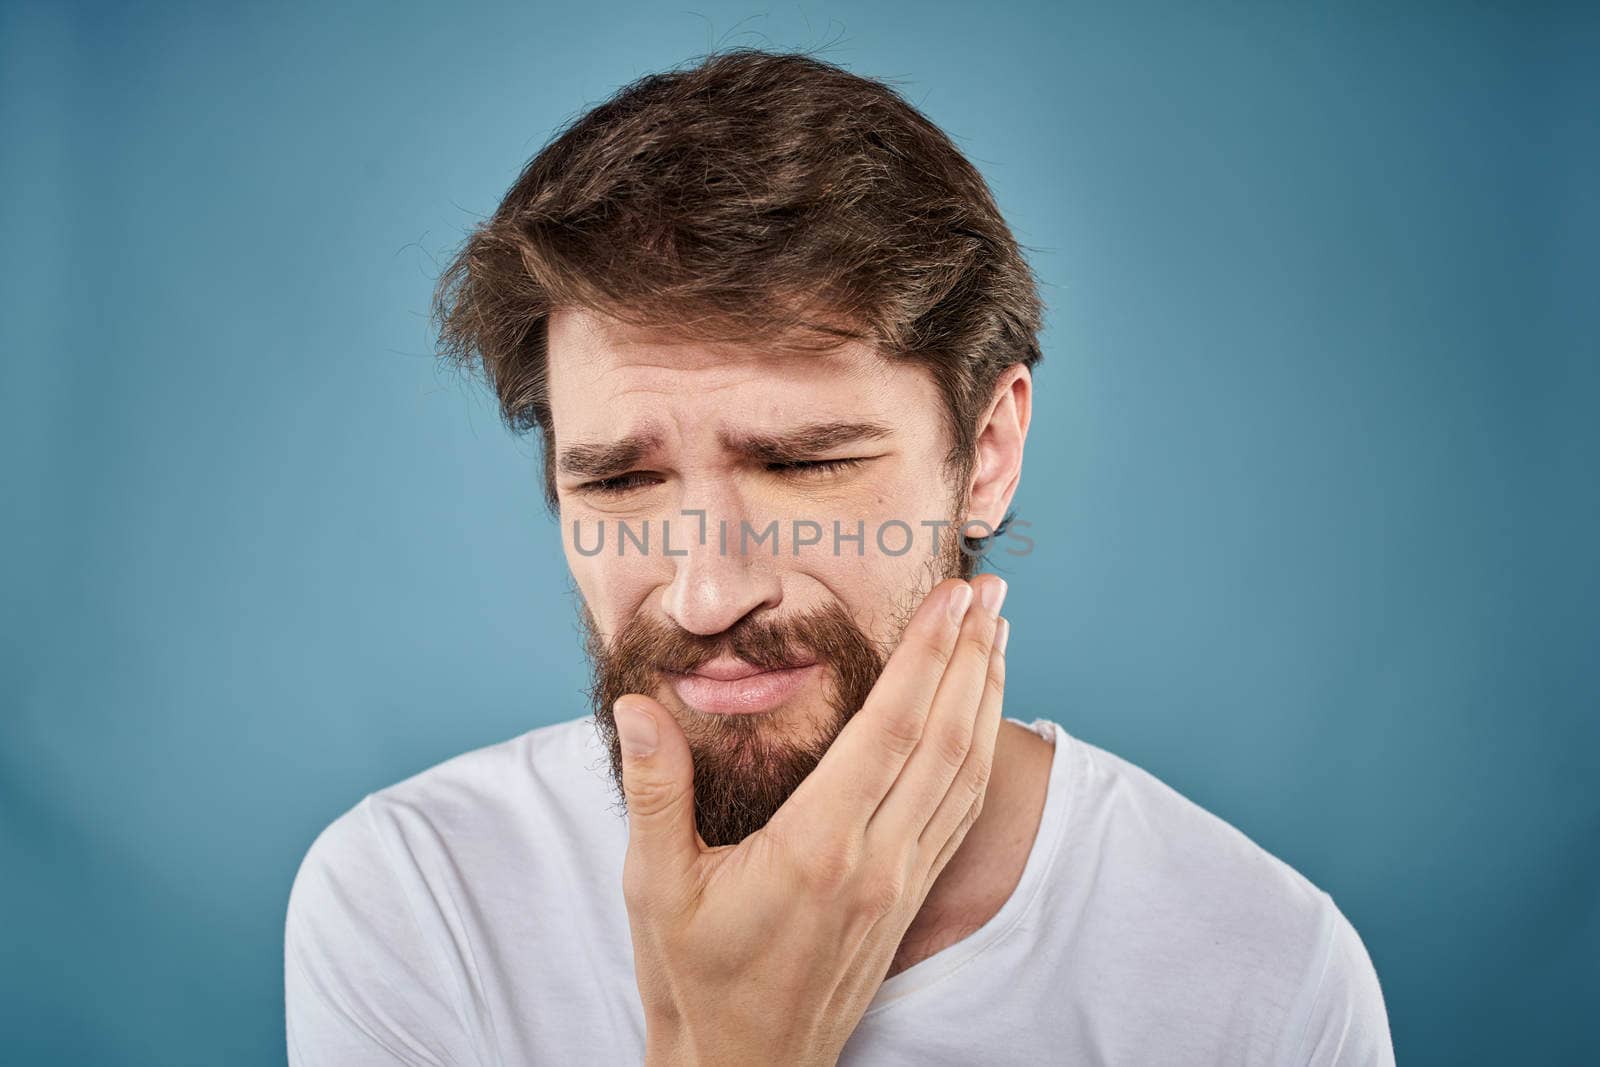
[549,310,960,845]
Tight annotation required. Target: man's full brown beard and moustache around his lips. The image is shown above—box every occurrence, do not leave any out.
[579,511,970,848]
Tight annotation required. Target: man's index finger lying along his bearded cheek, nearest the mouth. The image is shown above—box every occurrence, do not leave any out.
[773,579,973,841]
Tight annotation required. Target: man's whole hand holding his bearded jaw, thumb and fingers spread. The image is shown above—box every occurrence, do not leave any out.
[614,574,1008,1065]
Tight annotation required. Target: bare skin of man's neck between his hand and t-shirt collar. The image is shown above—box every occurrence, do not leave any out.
[888,720,1054,976]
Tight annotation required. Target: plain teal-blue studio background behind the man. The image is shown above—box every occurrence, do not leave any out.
[0,0,1600,1065]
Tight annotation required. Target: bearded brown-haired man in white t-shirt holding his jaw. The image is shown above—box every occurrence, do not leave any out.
[285,50,1394,1065]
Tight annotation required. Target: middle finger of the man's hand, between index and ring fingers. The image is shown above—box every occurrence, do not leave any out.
[867,574,1005,851]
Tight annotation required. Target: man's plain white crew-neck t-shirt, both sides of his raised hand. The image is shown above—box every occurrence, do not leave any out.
[285,718,1394,1067]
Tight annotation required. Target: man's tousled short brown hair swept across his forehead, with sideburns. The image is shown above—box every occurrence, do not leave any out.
[434,48,1043,556]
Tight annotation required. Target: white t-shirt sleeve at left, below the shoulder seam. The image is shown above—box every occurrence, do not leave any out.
[283,798,478,1067]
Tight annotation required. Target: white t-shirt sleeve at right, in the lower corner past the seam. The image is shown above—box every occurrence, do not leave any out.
[1288,899,1395,1067]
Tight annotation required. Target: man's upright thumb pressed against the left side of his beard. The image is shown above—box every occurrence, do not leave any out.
[611,693,699,883]
